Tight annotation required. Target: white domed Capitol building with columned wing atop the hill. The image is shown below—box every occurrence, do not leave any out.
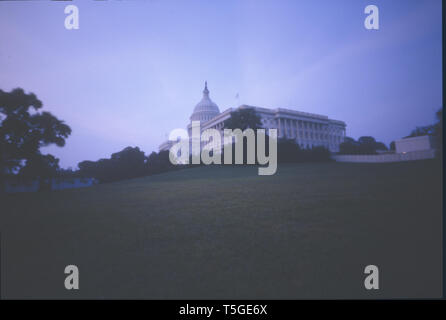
[159,83,346,152]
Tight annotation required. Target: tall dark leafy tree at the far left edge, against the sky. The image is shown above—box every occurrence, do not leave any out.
[0,88,71,174]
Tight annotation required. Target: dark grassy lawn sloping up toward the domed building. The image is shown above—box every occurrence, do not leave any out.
[0,161,442,299]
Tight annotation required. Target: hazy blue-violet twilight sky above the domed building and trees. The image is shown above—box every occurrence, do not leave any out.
[0,0,442,168]
